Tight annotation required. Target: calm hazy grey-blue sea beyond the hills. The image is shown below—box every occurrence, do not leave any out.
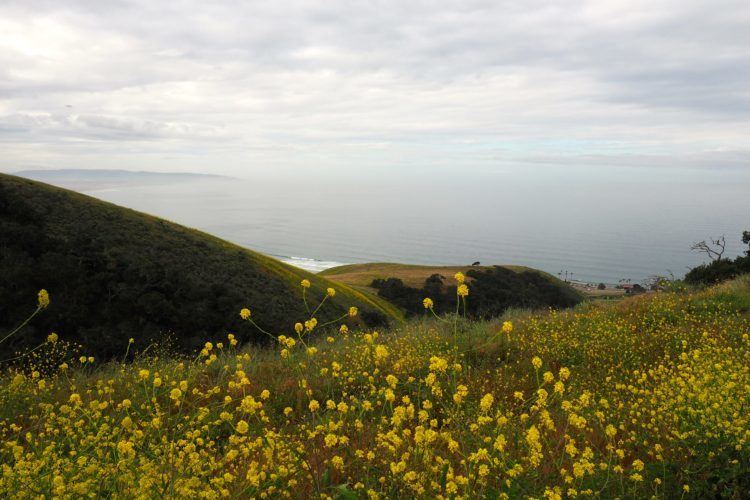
[79,170,750,283]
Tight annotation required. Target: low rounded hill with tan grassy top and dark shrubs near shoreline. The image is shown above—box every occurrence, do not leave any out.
[320,263,584,318]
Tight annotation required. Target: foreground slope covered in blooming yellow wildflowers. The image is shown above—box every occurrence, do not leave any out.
[0,276,750,499]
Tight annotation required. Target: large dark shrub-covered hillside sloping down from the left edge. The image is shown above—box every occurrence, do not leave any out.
[0,174,401,358]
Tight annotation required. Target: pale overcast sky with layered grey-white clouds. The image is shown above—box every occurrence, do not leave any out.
[0,0,750,180]
